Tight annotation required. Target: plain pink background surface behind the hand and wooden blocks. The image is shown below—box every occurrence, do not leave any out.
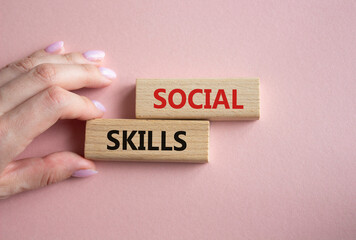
[0,0,356,240]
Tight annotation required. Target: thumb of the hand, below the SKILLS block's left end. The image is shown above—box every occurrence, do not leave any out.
[0,152,97,199]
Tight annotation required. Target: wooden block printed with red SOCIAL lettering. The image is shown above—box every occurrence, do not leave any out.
[136,79,260,120]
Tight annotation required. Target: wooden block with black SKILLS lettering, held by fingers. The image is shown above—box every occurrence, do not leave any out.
[84,119,209,163]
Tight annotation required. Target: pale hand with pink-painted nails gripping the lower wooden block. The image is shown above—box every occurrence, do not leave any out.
[0,42,116,199]
